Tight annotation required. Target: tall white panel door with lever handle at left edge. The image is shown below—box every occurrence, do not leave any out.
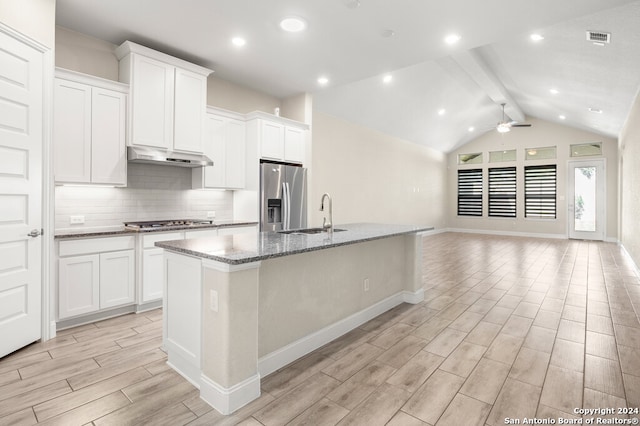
[0,29,44,358]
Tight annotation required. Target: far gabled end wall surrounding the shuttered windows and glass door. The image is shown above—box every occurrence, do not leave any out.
[447,117,618,240]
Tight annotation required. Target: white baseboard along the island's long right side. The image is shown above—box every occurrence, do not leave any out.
[258,289,424,377]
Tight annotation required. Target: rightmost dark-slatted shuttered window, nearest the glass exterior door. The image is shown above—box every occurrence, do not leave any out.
[524,164,556,219]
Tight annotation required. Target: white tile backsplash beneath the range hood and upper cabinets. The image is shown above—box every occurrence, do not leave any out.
[55,163,233,231]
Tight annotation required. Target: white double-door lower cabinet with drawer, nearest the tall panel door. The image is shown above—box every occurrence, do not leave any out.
[58,236,135,319]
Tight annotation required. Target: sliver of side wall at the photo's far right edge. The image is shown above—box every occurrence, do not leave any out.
[619,90,640,267]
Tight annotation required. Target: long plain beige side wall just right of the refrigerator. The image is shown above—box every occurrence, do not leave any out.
[309,111,447,228]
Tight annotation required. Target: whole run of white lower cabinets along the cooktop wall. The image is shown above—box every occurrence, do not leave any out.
[57,224,257,320]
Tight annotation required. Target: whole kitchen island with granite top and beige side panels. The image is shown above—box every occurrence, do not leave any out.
[156,224,432,414]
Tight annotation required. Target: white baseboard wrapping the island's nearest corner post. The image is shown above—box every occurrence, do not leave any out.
[200,374,260,416]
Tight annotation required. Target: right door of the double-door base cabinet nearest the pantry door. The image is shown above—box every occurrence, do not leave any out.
[100,250,135,309]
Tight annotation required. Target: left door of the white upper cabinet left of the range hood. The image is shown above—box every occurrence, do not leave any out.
[53,79,91,183]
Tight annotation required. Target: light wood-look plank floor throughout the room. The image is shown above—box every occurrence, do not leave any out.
[0,234,640,426]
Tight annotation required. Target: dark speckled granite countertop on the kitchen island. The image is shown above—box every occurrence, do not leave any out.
[155,223,433,265]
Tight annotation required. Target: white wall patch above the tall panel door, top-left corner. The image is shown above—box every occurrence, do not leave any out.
[0,0,56,48]
